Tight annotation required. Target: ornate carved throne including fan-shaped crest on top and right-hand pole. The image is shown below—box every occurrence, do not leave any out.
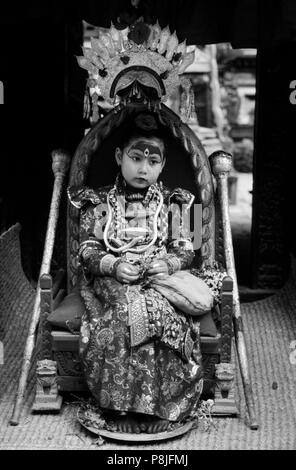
[23,25,257,429]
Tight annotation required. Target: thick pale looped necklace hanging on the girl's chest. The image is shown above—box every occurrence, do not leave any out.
[104,181,163,253]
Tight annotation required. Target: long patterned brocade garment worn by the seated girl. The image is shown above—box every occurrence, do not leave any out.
[69,182,212,421]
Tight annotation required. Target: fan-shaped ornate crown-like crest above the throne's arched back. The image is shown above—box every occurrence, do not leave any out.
[77,21,194,115]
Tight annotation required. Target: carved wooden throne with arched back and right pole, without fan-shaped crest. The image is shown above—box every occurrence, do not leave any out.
[33,103,257,429]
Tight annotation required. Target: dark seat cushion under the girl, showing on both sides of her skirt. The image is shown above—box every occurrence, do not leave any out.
[48,290,218,337]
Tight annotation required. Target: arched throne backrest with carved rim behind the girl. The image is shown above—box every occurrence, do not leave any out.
[67,105,217,291]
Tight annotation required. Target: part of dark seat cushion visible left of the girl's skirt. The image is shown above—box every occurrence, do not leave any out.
[48,290,85,333]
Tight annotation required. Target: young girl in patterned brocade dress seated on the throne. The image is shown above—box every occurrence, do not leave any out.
[69,114,214,432]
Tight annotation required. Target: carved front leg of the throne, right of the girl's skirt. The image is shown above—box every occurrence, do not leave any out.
[212,362,238,415]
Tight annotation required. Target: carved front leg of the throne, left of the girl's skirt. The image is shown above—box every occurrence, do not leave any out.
[32,359,63,411]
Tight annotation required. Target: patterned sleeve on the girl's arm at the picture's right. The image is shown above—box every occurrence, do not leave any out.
[166,188,195,274]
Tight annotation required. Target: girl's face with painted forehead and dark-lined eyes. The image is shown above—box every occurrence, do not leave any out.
[115,137,165,189]
